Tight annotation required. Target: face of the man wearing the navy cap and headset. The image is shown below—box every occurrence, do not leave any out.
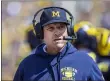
[44,23,68,48]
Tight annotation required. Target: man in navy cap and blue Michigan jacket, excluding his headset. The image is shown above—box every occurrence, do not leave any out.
[14,7,104,81]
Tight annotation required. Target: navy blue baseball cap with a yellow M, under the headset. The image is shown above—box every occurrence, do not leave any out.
[40,8,69,27]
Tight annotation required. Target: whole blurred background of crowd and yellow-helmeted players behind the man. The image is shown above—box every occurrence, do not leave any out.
[1,0,110,81]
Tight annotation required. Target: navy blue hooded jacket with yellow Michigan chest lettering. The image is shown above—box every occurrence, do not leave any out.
[14,43,104,81]
